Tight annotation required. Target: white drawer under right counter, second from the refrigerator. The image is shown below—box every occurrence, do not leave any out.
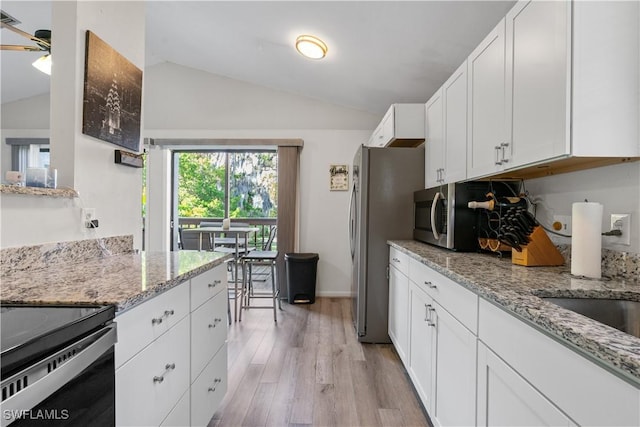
[409,258,478,334]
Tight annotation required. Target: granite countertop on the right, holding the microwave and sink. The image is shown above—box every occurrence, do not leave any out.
[388,240,640,385]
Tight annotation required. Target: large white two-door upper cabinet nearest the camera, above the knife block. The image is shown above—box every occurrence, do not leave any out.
[467,0,640,178]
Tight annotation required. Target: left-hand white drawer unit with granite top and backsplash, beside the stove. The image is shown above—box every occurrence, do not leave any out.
[2,238,231,426]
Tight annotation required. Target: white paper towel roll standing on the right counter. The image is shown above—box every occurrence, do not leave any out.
[571,202,603,279]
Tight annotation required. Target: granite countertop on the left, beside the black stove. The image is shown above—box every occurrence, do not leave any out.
[1,251,231,314]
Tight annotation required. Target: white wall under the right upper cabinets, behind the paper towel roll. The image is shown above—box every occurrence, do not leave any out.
[525,162,640,253]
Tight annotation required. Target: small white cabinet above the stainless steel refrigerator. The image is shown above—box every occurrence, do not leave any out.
[367,104,424,147]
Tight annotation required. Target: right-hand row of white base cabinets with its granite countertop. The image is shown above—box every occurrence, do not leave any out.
[388,240,640,425]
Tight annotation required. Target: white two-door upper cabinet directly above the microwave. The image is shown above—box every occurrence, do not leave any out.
[425,61,467,188]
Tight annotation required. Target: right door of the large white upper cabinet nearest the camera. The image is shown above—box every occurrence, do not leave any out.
[503,1,571,168]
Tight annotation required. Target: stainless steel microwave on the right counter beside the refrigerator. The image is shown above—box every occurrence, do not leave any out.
[413,181,496,252]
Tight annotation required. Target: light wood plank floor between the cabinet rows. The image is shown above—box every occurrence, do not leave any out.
[209,298,429,427]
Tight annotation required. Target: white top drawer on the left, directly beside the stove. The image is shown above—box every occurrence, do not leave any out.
[115,283,189,368]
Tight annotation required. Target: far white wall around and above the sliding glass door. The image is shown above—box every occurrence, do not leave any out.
[144,64,380,296]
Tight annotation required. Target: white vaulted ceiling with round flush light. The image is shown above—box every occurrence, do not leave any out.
[0,0,514,114]
